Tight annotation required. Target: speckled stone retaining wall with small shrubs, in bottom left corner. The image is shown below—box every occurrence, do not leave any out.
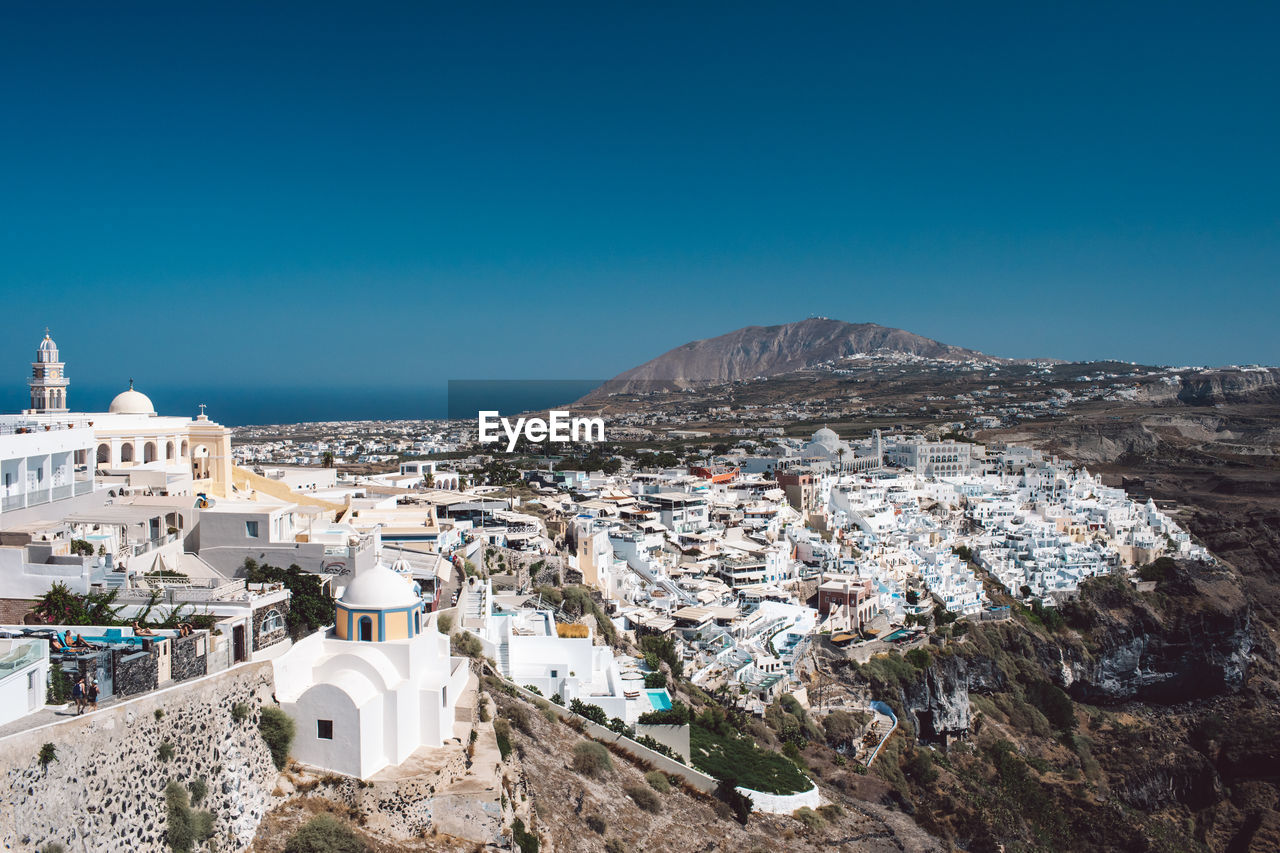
[0,662,276,853]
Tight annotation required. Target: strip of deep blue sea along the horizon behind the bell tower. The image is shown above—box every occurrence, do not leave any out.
[0,377,602,427]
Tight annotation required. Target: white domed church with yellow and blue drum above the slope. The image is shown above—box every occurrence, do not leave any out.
[273,564,471,779]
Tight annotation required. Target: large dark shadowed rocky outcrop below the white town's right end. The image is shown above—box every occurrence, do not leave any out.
[1039,561,1253,703]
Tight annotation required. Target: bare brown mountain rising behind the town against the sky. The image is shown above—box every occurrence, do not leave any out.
[593,318,1000,396]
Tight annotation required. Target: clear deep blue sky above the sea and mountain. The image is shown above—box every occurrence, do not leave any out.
[0,1,1280,409]
